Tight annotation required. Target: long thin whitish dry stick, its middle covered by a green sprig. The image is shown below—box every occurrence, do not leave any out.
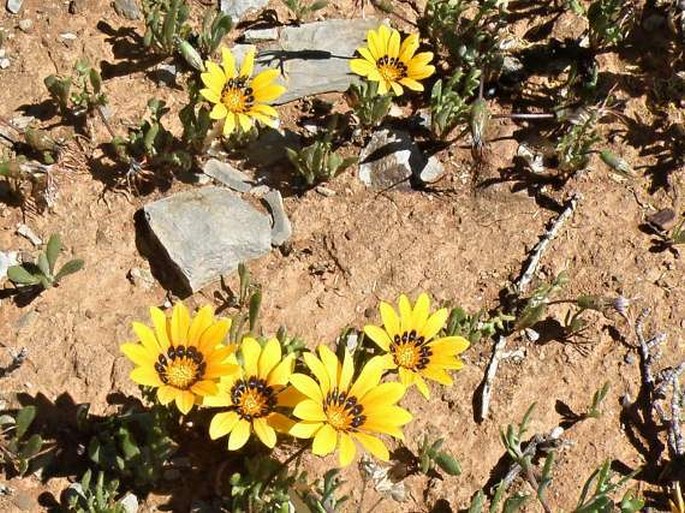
[480,193,583,421]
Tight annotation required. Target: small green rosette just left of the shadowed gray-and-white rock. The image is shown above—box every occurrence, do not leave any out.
[286,115,357,185]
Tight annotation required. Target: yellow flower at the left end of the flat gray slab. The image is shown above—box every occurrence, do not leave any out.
[200,48,285,135]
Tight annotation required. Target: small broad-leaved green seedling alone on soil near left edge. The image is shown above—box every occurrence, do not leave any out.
[7,233,83,289]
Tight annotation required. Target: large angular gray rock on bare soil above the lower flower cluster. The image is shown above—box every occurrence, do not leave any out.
[143,186,271,292]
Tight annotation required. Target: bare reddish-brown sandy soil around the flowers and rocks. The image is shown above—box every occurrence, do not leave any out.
[0,0,685,511]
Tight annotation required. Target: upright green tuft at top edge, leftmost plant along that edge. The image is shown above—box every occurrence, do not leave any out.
[142,0,191,56]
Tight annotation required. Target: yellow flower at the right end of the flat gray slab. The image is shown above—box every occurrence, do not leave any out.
[350,25,435,96]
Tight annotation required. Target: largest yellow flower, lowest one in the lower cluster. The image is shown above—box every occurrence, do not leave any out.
[290,346,412,466]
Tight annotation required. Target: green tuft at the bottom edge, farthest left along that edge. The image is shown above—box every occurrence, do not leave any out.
[64,469,127,513]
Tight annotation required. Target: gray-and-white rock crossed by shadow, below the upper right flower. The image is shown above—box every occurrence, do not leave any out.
[359,128,444,190]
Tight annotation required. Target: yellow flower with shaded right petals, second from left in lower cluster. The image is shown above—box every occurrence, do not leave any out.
[203,337,302,451]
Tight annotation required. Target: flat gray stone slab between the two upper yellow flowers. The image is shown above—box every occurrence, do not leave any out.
[257,18,380,104]
